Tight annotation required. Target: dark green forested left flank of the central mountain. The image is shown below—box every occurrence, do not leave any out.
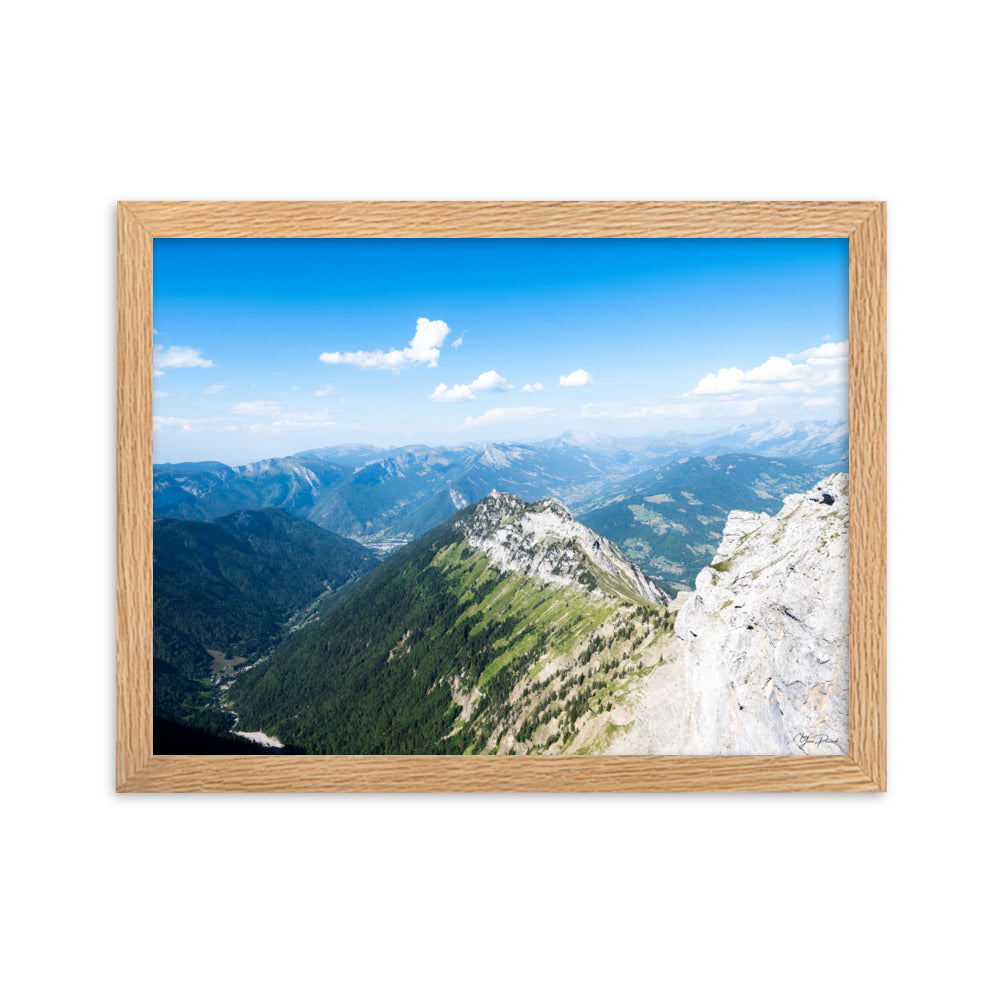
[230,515,474,753]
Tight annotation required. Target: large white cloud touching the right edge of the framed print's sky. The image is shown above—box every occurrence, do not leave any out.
[685,340,847,397]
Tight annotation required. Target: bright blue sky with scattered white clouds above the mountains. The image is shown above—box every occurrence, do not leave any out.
[153,239,848,464]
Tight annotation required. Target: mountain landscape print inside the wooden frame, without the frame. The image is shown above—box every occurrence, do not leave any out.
[152,240,849,755]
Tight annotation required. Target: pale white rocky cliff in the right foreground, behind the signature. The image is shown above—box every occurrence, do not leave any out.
[610,473,848,754]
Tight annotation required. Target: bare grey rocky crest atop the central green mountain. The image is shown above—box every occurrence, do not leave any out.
[459,490,666,604]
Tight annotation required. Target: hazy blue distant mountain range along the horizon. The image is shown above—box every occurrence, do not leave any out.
[153,421,847,552]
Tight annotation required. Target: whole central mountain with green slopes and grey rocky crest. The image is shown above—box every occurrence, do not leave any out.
[229,494,669,754]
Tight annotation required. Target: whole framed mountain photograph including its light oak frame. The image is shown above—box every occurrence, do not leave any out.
[116,202,886,792]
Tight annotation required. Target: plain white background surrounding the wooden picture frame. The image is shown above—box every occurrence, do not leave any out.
[0,0,998,1000]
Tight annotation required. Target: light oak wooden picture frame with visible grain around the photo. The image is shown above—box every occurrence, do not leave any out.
[116,201,886,792]
